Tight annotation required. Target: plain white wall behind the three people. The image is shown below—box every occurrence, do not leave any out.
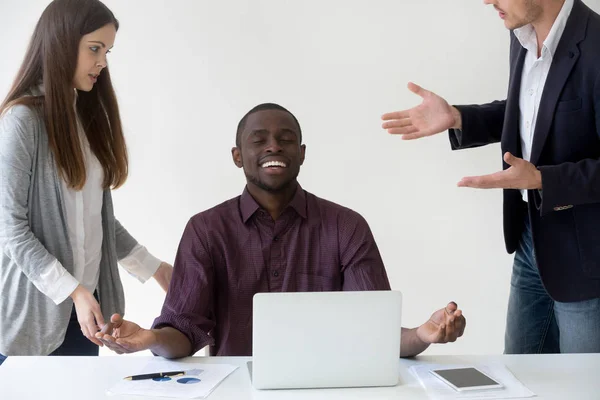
[0,0,600,354]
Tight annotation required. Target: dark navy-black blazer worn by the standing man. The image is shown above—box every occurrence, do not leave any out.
[450,0,600,302]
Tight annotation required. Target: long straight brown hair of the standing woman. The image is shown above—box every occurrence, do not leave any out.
[0,0,128,190]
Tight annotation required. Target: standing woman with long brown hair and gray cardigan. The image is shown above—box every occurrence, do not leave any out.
[0,0,172,364]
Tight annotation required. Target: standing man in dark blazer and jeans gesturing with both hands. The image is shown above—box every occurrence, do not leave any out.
[382,0,600,353]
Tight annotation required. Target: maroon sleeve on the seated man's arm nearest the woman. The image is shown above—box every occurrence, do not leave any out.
[153,215,215,354]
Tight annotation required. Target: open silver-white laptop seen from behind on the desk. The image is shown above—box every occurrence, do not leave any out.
[248,291,402,389]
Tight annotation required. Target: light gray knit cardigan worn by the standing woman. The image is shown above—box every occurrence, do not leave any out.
[0,105,137,356]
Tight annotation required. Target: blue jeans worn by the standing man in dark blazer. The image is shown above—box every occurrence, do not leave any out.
[504,217,600,354]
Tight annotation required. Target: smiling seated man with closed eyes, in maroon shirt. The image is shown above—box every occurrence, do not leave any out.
[96,103,466,358]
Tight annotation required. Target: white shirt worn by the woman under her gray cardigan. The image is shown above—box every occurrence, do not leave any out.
[38,109,161,304]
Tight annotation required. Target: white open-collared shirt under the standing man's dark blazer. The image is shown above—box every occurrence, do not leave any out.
[514,0,574,201]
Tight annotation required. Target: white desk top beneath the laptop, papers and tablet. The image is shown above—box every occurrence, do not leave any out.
[0,354,600,400]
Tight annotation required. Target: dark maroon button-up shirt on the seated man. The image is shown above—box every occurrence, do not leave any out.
[154,187,390,356]
